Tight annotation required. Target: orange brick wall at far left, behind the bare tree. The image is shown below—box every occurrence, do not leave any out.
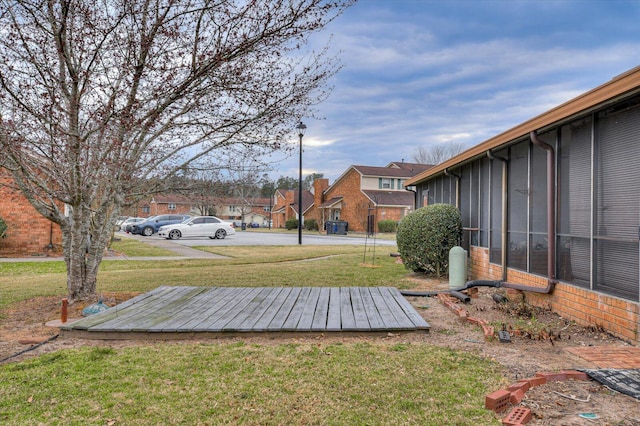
[0,171,62,257]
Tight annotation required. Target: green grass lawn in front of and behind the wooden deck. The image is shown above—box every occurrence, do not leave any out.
[0,243,505,425]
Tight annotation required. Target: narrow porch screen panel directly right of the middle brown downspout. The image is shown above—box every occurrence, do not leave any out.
[508,142,529,270]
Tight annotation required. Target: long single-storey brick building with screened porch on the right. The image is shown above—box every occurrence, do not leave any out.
[404,67,640,344]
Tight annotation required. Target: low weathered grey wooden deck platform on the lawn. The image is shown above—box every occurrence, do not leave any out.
[60,287,429,339]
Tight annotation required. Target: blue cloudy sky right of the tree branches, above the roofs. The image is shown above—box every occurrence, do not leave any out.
[271,0,640,183]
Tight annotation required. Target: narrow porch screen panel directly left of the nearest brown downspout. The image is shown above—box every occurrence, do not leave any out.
[529,131,556,275]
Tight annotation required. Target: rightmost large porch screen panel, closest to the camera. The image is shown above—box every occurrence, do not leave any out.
[594,108,640,301]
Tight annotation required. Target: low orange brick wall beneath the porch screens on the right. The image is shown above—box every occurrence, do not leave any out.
[469,247,640,344]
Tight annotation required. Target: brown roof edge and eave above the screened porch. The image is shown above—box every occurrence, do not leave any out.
[404,66,640,186]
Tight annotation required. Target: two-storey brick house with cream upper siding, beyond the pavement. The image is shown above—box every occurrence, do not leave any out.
[314,162,432,232]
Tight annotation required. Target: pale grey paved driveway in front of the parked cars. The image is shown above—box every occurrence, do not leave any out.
[121,231,396,247]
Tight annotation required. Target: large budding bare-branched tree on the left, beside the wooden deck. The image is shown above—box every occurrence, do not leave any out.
[0,0,355,301]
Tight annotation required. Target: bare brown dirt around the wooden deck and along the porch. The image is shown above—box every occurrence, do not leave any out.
[0,277,640,425]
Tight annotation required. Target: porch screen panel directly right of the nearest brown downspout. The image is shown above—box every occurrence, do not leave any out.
[556,118,592,288]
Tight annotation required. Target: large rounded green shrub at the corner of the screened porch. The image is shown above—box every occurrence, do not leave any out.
[396,204,462,276]
